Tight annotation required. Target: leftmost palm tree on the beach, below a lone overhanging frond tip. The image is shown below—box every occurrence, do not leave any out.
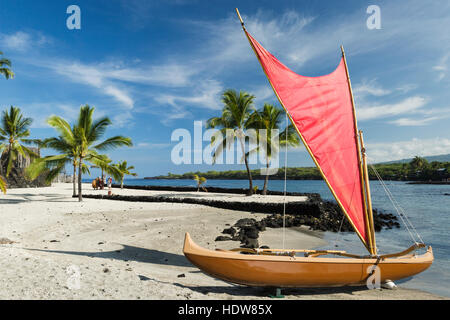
[0,106,39,177]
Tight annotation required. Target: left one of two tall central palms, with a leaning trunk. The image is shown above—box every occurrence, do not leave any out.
[206,89,255,195]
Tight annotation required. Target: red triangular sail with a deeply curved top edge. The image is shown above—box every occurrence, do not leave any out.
[246,32,369,245]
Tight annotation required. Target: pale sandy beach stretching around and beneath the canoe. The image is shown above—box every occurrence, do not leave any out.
[0,184,441,300]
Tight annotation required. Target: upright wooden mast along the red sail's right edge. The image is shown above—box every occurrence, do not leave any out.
[341,45,376,255]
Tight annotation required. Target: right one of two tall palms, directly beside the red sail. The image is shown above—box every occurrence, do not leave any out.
[250,103,300,195]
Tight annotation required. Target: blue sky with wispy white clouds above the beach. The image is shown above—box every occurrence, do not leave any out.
[0,0,450,177]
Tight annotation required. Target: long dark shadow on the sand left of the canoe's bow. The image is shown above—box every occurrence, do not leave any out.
[24,244,192,267]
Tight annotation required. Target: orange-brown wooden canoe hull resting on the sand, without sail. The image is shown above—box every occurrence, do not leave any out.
[183,233,433,287]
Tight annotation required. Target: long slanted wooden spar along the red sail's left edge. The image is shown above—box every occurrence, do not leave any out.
[236,8,371,252]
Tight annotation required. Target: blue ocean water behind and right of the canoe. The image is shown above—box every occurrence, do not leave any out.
[120,179,450,297]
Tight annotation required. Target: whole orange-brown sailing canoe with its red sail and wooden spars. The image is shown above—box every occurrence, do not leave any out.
[183,9,433,288]
